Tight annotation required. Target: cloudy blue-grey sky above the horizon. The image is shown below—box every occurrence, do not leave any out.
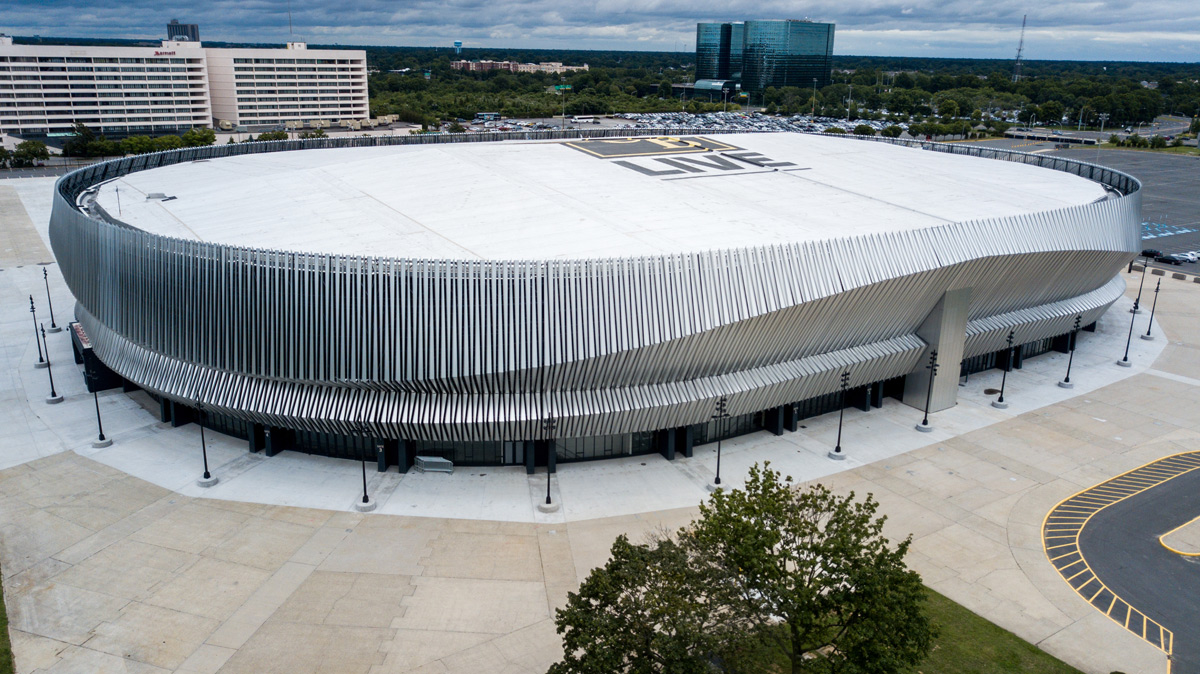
[0,0,1200,62]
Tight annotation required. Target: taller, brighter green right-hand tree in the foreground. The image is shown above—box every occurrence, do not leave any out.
[682,463,935,674]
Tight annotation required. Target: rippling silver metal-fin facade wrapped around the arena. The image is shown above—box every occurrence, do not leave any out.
[50,130,1141,458]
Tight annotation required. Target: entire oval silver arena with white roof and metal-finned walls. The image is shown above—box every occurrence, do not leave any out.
[50,130,1141,470]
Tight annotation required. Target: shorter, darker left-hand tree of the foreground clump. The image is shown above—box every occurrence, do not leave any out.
[548,535,718,674]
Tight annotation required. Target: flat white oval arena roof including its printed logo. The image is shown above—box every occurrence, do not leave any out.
[98,133,1105,259]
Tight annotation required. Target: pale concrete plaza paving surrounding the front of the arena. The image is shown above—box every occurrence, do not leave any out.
[0,176,1200,674]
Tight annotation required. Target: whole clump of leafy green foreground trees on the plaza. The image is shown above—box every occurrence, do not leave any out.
[550,464,935,674]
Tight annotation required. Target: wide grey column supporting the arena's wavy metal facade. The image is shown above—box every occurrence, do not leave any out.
[904,288,971,413]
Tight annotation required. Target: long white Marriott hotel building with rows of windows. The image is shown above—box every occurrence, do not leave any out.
[0,36,368,137]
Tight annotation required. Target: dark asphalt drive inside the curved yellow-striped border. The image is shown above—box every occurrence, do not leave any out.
[1079,470,1200,674]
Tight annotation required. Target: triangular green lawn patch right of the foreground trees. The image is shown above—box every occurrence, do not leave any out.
[914,590,1081,674]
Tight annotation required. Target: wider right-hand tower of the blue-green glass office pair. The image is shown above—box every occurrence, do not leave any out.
[742,20,834,91]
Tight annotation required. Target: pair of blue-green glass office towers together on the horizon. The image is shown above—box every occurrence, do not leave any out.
[696,19,834,91]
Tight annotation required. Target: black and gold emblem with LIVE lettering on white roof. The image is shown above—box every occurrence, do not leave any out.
[566,136,800,180]
